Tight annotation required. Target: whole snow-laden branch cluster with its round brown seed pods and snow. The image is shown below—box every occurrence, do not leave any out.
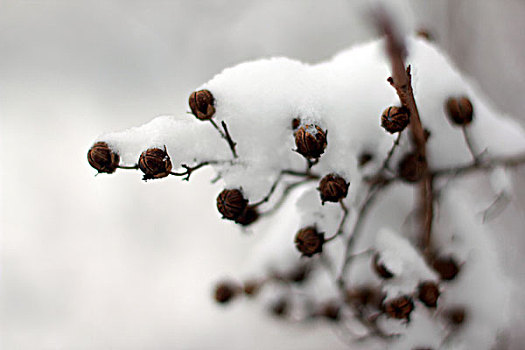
[88,20,525,349]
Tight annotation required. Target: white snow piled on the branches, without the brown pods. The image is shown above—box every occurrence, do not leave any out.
[91,38,525,349]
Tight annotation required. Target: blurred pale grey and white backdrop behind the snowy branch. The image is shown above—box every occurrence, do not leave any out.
[0,0,525,349]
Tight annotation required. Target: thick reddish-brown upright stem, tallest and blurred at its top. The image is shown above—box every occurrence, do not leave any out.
[376,11,434,253]
